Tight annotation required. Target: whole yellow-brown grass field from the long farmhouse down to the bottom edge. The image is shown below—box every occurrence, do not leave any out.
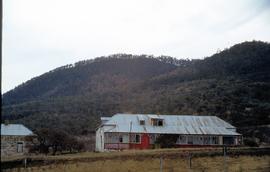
[3,149,270,172]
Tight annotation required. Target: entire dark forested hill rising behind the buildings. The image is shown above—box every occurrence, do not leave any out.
[2,41,270,141]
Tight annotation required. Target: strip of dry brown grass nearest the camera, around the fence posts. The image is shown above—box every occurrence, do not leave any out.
[6,156,270,172]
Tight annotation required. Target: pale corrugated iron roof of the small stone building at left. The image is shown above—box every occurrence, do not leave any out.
[1,124,33,136]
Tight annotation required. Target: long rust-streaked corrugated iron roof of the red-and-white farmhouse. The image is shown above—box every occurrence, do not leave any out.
[101,114,240,135]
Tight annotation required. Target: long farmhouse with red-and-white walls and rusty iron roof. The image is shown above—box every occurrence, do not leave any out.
[96,114,242,151]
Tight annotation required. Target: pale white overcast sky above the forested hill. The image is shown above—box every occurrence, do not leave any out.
[2,0,270,93]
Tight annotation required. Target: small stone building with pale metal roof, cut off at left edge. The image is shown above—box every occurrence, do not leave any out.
[1,124,35,157]
